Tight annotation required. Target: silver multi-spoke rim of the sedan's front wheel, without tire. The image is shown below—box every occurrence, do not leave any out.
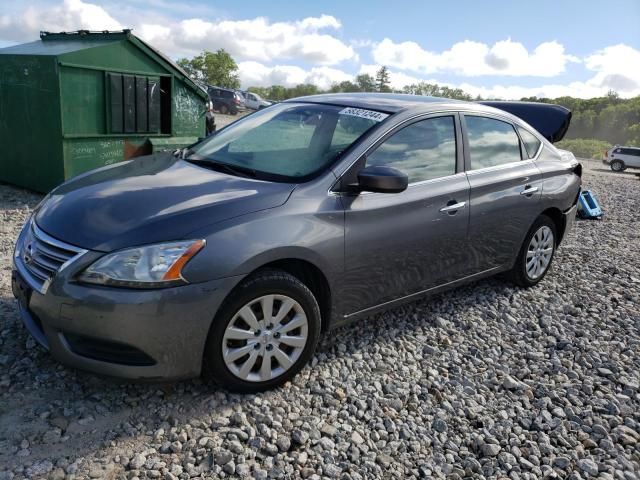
[222,294,309,382]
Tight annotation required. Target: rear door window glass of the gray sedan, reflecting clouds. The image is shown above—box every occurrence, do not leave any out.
[465,116,521,170]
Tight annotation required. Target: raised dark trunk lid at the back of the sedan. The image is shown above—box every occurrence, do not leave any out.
[478,101,571,143]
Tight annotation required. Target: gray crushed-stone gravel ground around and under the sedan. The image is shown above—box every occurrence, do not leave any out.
[0,159,640,480]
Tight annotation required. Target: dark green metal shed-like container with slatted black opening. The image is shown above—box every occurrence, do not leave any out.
[0,30,208,192]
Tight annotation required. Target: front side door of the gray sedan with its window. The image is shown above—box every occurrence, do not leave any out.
[341,114,469,315]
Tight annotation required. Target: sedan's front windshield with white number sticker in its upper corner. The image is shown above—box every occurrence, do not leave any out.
[186,103,388,181]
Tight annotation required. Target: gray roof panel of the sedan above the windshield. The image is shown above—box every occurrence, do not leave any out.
[287,93,467,113]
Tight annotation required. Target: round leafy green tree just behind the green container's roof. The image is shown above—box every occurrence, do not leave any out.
[178,48,240,88]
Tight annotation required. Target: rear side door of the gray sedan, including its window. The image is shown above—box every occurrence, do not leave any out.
[462,114,543,273]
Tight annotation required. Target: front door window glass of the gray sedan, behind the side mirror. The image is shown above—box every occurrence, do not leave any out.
[367,117,456,183]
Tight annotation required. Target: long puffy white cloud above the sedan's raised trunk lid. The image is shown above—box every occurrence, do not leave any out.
[372,38,578,77]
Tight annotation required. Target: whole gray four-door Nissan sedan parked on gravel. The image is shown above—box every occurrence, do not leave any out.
[12,94,581,392]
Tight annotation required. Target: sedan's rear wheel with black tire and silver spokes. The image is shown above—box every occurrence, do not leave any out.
[507,215,558,288]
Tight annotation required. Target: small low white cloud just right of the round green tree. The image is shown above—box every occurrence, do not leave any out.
[238,61,353,89]
